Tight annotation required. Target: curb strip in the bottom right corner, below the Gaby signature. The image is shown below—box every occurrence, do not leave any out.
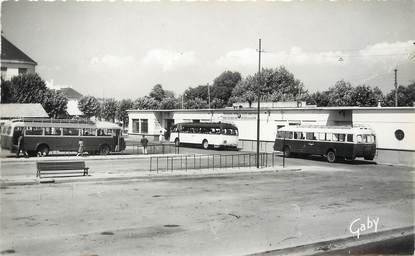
[249,226,414,256]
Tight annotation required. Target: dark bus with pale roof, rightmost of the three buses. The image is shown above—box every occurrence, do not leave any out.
[274,126,376,163]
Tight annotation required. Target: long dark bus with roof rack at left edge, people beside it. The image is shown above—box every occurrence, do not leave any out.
[1,119,125,156]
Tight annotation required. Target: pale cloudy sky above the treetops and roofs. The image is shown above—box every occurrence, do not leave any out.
[1,1,415,99]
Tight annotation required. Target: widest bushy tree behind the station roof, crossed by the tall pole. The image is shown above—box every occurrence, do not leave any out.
[232,66,307,105]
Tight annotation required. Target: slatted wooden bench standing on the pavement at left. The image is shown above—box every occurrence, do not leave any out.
[36,161,89,178]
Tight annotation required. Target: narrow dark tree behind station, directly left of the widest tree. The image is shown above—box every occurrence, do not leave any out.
[210,71,242,105]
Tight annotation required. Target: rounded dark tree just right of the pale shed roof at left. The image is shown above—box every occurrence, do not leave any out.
[42,89,68,118]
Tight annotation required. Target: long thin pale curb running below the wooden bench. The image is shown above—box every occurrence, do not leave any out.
[0,168,302,188]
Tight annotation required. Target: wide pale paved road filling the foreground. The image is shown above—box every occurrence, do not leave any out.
[0,159,414,255]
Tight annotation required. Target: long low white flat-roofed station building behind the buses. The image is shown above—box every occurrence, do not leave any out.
[128,102,415,166]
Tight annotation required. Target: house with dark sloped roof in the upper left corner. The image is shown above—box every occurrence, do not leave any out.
[1,35,37,80]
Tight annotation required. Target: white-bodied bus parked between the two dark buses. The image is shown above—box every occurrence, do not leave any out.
[170,123,239,149]
